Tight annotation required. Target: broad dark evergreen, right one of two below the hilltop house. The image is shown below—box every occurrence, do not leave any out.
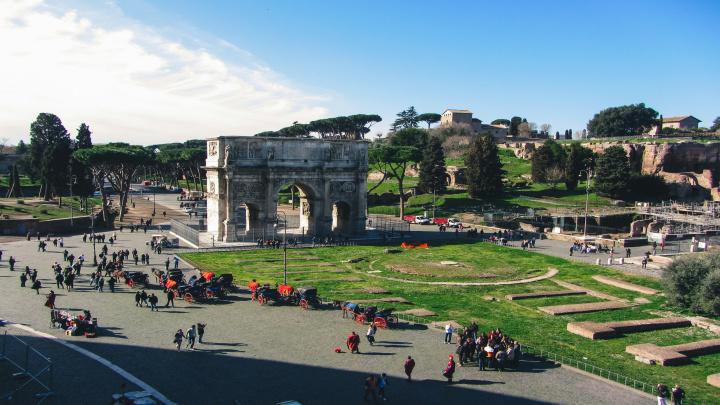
[465,134,503,198]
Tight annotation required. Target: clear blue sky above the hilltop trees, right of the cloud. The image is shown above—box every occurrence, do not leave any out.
[0,0,720,142]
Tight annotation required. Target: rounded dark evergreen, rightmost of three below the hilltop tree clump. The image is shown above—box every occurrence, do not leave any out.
[595,146,631,198]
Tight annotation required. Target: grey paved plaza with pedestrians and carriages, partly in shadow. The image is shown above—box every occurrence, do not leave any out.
[0,232,651,404]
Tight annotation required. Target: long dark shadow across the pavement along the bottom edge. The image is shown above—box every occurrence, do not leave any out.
[9,337,544,405]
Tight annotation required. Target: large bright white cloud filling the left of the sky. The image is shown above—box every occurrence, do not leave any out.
[0,0,327,144]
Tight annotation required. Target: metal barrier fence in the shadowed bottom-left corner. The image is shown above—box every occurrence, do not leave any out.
[0,331,54,404]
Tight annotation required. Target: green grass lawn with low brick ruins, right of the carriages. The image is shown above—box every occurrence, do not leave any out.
[182,242,720,403]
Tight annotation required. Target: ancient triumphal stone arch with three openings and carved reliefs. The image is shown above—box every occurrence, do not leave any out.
[206,136,368,242]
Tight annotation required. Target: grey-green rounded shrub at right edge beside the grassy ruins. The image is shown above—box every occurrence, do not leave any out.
[663,253,720,316]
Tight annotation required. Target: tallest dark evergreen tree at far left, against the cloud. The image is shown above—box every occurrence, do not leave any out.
[30,113,72,201]
